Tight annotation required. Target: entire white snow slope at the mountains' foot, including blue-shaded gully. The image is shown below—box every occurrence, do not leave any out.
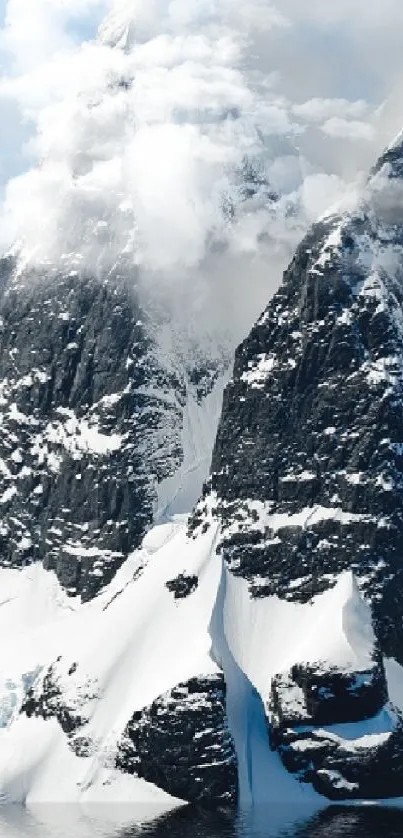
[0,496,394,812]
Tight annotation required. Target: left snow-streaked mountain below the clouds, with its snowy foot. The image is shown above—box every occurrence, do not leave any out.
[0,256,237,808]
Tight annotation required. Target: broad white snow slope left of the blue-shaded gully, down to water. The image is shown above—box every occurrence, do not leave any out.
[0,519,220,803]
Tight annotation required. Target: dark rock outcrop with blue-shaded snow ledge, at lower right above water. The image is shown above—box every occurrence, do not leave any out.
[267,663,403,800]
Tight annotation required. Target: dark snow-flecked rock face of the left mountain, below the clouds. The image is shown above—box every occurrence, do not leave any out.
[0,260,226,600]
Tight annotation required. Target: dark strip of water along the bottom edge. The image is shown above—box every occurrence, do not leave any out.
[0,806,403,838]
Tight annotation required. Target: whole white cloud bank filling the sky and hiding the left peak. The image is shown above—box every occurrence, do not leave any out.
[0,0,403,348]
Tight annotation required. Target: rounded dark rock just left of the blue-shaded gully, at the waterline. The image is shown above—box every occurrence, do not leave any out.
[117,675,238,805]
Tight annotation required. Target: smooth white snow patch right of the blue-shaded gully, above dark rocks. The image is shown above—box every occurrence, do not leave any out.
[224,572,375,700]
